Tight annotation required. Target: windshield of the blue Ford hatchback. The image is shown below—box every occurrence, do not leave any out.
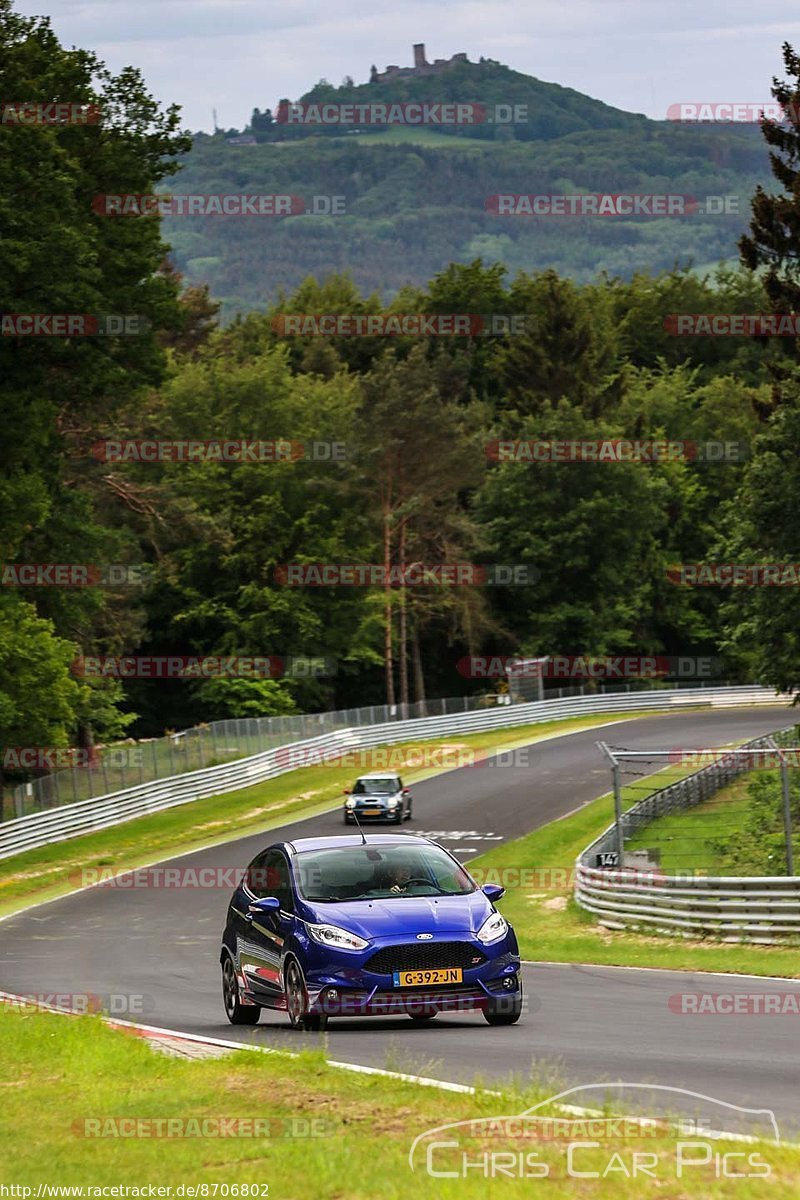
[294,839,476,902]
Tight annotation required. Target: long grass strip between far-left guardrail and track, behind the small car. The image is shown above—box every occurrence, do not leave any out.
[0,713,654,916]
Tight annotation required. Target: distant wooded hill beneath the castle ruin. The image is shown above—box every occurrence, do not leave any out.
[166,47,769,319]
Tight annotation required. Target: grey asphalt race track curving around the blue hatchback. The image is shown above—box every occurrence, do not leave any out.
[0,707,800,1136]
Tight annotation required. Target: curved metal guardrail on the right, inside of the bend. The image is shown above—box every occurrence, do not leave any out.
[575,726,800,944]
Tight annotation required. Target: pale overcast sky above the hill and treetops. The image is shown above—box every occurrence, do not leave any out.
[17,0,800,130]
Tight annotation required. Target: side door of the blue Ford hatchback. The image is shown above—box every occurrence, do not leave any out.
[239,850,295,1003]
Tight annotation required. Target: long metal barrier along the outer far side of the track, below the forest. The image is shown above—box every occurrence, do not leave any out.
[0,686,789,858]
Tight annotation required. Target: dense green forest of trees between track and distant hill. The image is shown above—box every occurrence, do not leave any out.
[0,0,800,782]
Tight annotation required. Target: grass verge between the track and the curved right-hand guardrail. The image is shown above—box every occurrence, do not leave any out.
[469,767,800,978]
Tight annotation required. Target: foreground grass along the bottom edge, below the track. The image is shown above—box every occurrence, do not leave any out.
[0,1010,800,1200]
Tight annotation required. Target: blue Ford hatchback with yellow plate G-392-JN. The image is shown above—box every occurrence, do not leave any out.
[219,834,522,1030]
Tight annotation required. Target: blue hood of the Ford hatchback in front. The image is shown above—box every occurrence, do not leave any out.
[299,890,492,940]
